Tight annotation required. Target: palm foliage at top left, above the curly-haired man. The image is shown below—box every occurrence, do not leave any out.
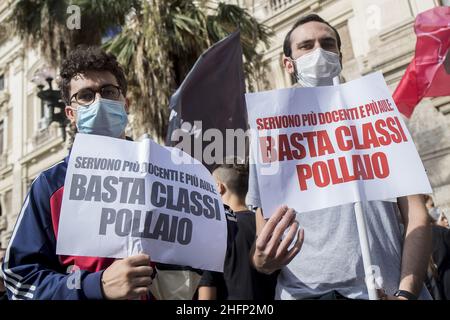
[10,0,139,64]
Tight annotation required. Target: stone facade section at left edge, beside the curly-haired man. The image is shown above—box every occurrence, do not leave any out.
[0,0,67,248]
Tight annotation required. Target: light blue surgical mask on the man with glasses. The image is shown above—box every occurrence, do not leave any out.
[77,98,128,138]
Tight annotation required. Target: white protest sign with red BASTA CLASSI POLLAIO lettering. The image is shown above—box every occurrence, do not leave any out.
[246,73,431,215]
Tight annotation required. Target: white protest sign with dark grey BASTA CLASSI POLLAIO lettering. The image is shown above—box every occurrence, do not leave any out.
[57,134,227,271]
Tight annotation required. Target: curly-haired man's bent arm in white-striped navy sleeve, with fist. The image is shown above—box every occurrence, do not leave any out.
[2,175,153,300]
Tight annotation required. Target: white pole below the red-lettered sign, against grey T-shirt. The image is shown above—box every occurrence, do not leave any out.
[355,202,378,300]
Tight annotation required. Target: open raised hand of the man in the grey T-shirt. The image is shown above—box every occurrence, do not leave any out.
[251,206,304,274]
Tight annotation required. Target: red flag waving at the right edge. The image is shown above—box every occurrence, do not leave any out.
[393,7,450,118]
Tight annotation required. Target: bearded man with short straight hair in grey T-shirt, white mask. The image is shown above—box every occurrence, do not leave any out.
[247,14,431,300]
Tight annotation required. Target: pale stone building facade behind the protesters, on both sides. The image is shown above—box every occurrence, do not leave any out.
[0,0,450,248]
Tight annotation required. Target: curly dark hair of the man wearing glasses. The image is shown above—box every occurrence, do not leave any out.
[59,46,127,105]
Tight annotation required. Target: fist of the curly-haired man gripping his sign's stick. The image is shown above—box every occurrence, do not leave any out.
[102,254,153,300]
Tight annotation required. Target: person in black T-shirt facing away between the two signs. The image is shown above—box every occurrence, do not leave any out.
[198,159,277,300]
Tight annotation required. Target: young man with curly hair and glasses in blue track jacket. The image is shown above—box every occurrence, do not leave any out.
[2,47,153,300]
